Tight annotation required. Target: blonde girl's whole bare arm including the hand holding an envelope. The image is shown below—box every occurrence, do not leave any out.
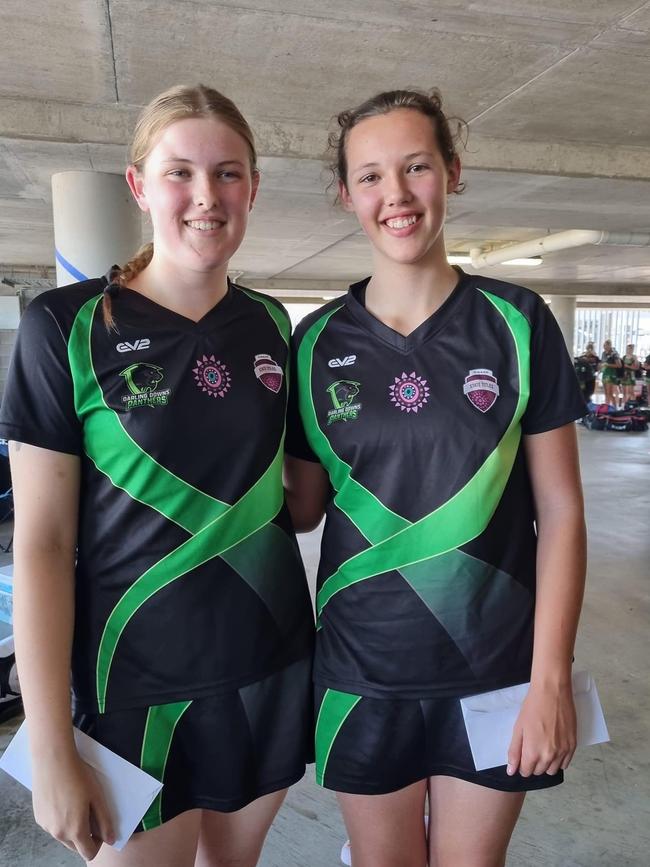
[9,442,112,859]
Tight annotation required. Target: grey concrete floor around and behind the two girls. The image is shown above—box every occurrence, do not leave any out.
[0,427,650,867]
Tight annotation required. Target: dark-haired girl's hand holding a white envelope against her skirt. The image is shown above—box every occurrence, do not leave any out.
[507,684,576,777]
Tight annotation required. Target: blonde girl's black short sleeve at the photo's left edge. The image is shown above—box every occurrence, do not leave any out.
[0,293,82,455]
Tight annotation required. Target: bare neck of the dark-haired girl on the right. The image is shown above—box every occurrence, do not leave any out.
[366,258,459,336]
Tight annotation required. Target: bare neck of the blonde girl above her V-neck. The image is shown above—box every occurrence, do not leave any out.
[129,255,228,322]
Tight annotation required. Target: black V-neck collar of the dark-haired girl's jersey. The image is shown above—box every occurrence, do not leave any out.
[345,268,471,355]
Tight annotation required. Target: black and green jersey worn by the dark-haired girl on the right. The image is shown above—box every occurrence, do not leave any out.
[287,275,584,698]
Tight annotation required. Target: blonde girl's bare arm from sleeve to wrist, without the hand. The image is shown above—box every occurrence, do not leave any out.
[9,442,79,754]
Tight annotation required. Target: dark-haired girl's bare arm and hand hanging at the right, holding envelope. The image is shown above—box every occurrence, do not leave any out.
[508,424,586,776]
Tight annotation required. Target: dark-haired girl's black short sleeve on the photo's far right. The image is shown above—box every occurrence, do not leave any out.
[521,298,587,434]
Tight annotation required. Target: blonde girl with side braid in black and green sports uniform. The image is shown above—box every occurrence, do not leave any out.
[0,86,313,867]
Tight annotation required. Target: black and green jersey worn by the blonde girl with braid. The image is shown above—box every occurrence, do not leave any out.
[0,280,313,712]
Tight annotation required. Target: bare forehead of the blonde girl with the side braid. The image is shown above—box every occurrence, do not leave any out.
[146,117,248,162]
